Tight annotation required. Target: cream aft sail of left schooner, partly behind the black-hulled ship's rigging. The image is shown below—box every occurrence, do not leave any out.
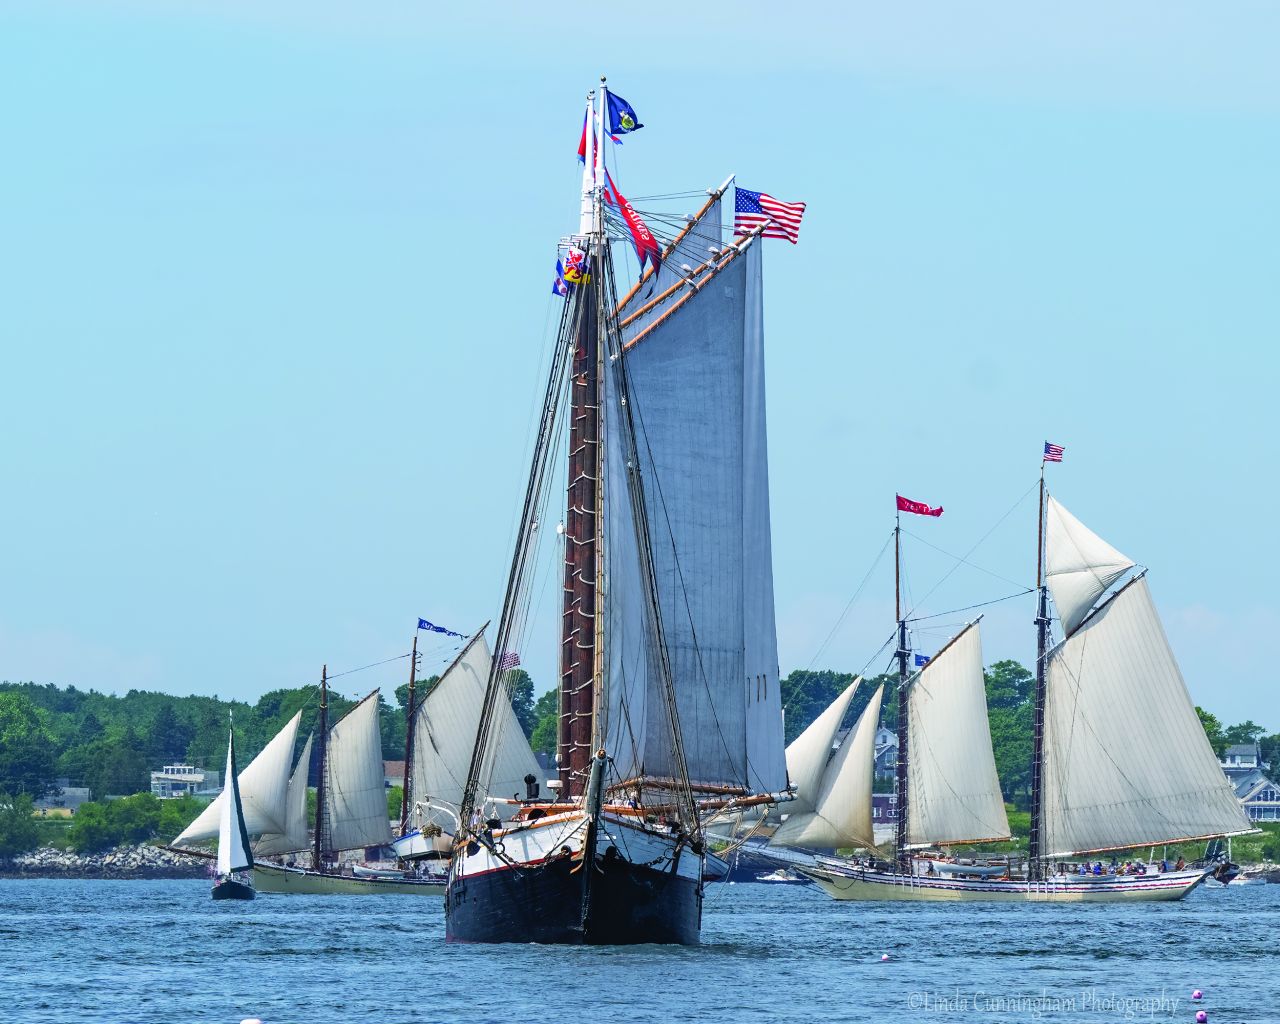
[410,634,544,808]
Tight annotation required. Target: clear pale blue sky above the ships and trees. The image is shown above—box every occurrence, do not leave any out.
[0,0,1280,731]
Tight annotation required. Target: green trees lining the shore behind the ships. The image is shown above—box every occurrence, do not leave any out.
[0,660,1280,856]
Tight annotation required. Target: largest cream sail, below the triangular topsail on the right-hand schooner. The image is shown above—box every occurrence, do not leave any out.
[1042,576,1251,856]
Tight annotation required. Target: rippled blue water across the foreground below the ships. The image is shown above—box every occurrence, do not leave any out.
[0,881,1280,1024]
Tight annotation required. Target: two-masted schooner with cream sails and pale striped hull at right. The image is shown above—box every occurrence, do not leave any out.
[801,476,1253,902]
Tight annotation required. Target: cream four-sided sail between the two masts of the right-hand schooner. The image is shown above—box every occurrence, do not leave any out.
[906,622,1009,846]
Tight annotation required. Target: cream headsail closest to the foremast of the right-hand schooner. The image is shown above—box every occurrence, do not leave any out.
[769,684,884,849]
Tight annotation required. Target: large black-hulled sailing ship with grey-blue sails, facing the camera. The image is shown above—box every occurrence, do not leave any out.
[445,79,790,943]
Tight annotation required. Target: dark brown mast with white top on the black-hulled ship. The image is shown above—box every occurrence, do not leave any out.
[558,81,605,797]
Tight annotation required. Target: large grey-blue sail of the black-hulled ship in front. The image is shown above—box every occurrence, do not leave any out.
[604,227,786,792]
